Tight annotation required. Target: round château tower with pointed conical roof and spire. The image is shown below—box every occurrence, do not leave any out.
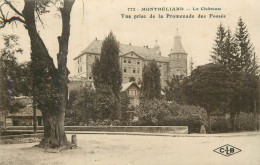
[169,29,188,76]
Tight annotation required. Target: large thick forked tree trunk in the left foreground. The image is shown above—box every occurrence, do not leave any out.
[1,0,74,148]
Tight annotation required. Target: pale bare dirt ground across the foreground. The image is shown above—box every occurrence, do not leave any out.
[0,134,260,165]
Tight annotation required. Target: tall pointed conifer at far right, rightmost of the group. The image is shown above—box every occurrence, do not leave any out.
[235,17,259,74]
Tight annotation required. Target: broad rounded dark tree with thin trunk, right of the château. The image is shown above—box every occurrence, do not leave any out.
[182,64,231,132]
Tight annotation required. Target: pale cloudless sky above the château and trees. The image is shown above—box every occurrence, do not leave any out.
[0,0,260,76]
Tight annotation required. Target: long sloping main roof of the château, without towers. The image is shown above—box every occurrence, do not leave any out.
[74,40,169,62]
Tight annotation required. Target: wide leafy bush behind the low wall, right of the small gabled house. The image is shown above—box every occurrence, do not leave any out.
[135,100,207,133]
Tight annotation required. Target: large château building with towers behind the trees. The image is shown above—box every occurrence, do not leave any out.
[74,31,188,87]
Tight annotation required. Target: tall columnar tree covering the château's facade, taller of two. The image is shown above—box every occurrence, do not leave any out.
[92,32,122,120]
